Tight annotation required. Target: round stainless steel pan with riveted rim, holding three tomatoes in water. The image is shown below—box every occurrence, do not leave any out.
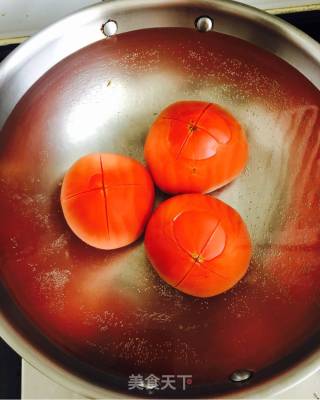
[0,0,320,397]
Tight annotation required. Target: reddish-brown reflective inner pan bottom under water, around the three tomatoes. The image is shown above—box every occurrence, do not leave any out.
[0,29,320,393]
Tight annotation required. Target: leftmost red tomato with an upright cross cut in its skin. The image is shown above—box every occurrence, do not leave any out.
[61,154,154,249]
